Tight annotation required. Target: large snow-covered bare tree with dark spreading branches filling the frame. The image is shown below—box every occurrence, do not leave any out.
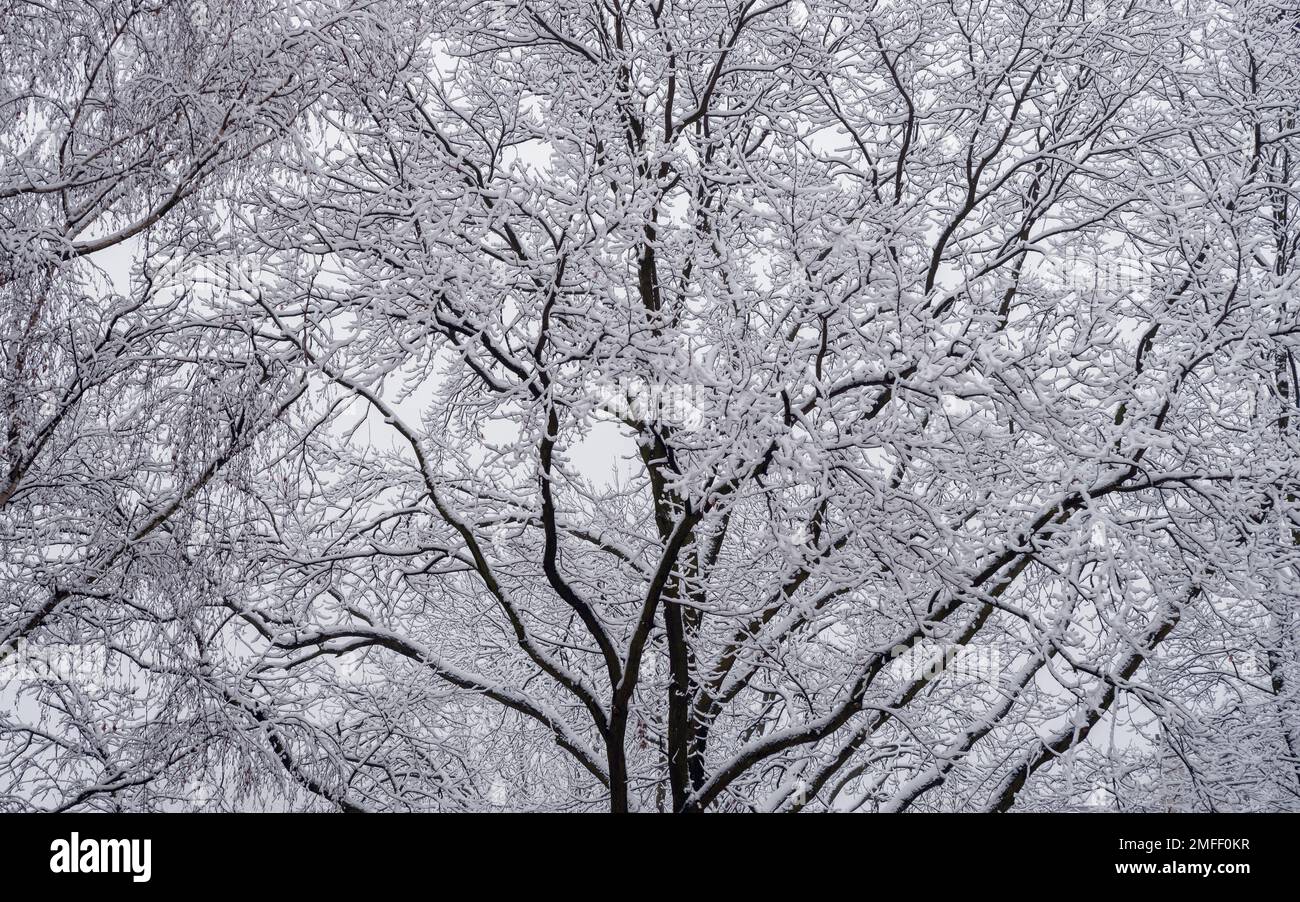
[0,0,1300,811]
